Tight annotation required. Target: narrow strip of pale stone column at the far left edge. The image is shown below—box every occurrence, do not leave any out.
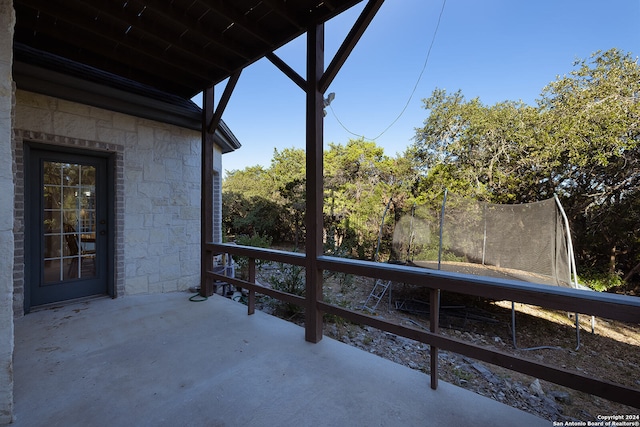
[0,0,15,424]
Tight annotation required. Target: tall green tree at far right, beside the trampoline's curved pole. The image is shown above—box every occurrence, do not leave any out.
[539,49,640,280]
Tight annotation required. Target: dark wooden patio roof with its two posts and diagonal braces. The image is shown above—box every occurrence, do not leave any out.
[14,0,384,342]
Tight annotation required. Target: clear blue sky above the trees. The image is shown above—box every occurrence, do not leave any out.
[196,0,640,175]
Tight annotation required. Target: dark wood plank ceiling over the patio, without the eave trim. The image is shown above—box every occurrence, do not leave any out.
[14,0,361,99]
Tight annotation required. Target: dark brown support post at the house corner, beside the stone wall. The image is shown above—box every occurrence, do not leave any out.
[200,87,215,297]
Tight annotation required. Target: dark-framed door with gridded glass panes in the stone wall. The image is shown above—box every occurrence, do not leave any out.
[25,149,110,311]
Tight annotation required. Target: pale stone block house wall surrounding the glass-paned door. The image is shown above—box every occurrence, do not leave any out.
[14,90,221,313]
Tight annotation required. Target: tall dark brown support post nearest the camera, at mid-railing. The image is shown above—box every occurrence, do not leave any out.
[305,24,324,343]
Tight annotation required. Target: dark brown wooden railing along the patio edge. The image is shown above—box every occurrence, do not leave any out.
[204,243,640,408]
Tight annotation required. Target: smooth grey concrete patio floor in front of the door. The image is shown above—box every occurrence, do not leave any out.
[13,292,551,427]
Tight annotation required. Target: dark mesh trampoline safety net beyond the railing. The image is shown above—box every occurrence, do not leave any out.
[393,193,575,287]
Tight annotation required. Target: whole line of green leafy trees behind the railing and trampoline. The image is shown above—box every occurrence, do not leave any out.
[223,49,640,286]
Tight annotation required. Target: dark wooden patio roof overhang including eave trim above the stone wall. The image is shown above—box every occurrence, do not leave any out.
[14,0,376,153]
